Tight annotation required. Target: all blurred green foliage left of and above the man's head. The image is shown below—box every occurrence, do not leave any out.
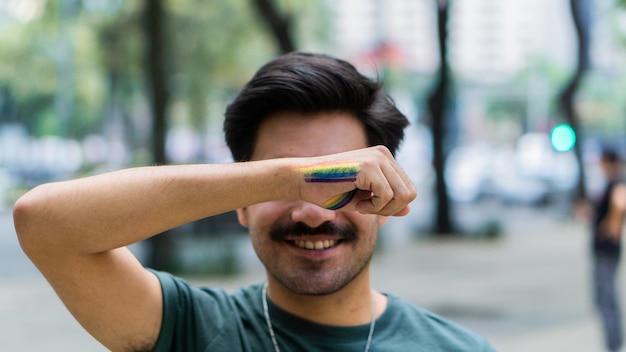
[0,0,328,142]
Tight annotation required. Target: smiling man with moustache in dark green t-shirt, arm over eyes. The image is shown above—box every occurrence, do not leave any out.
[14,53,493,352]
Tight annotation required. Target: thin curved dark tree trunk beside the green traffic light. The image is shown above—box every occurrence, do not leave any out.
[559,0,590,201]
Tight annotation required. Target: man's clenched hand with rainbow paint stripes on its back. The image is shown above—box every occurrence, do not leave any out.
[293,146,416,216]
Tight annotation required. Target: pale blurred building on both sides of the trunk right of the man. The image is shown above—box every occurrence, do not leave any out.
[327,0,575,80]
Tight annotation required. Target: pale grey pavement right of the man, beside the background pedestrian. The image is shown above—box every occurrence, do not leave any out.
[374,212,604,352]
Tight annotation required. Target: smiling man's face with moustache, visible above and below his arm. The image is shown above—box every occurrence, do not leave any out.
[238,113,386,295]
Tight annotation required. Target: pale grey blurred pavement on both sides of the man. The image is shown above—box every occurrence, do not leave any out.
[0,205,626,352]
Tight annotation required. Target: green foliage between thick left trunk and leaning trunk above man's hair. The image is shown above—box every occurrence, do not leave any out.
[168,0,273,128]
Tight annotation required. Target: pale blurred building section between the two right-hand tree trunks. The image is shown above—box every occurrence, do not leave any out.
[450,0,575,81]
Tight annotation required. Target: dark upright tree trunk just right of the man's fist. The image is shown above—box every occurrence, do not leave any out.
[428,1,454,235]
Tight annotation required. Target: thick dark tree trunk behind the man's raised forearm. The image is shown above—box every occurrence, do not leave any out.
[144,0,172,270]
